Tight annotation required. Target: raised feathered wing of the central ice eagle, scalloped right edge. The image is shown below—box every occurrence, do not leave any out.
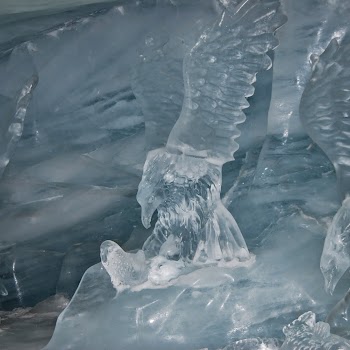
[167,0,286,164]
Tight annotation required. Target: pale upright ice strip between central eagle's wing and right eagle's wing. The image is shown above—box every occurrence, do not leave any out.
[268,0,350,139]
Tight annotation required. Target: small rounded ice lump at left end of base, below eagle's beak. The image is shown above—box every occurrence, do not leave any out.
[101,241,147,290]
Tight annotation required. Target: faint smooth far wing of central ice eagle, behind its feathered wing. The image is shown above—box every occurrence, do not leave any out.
[132,3,216,149]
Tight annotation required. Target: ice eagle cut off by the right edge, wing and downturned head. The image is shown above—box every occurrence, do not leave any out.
[300,38,350,293]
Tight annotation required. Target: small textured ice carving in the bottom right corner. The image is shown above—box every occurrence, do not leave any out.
[281,311,350,350]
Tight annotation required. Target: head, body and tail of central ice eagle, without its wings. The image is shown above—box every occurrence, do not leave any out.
[137,149,249,263]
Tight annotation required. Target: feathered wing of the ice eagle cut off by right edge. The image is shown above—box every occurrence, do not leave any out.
[300,39,350,166]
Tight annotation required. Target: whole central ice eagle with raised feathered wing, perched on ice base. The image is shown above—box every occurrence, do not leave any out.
[137,0,286,263]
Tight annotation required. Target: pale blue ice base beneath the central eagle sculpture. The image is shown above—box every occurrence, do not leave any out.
[46,198,345,350]
